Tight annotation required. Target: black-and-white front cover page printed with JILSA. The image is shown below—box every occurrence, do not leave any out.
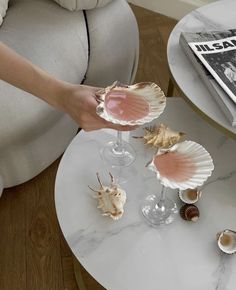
[188,29,236,104]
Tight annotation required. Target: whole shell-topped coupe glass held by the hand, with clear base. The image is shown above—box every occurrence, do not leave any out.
[96,82,166,167]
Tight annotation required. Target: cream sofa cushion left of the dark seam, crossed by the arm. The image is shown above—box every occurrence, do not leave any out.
[0,0,88,150]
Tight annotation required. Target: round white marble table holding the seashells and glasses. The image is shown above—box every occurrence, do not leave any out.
[55,98,236,290]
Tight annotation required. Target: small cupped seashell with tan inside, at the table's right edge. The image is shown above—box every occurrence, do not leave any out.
[217,229,236,254]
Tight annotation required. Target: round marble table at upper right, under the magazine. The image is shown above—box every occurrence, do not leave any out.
[167,0,236,139]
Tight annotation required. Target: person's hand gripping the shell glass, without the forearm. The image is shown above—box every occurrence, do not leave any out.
[59,85,136,131]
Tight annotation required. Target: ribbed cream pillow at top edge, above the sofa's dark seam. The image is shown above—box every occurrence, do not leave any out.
[53,0,112,11]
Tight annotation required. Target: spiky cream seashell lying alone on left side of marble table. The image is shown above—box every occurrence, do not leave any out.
[89,173,126,220]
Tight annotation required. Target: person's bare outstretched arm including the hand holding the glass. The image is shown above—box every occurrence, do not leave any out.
[0,42,133,131]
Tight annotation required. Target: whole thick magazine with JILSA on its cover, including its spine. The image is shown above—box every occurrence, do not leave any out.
[179,29,236,126]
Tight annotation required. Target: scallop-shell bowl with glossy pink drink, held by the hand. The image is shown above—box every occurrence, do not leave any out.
[96,82,166,125]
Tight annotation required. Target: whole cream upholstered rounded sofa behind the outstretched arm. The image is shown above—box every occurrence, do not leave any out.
[0,0,138,192]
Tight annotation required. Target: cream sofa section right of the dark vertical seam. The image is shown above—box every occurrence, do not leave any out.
[86,0,139,86]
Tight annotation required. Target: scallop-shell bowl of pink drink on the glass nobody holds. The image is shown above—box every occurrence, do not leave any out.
[148,141,214,190]
